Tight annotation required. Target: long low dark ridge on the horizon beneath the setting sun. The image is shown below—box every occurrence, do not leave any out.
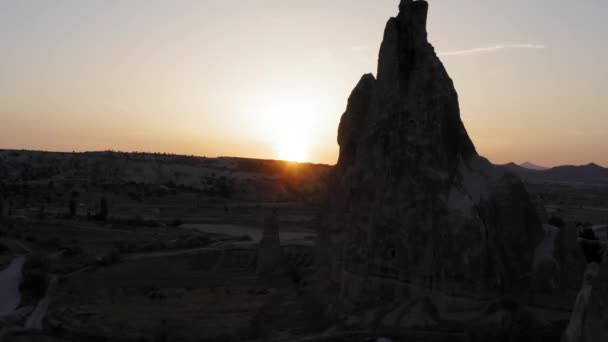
[0,149,331,201]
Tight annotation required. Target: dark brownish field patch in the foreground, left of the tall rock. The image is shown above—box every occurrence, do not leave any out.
[49,250,324,340]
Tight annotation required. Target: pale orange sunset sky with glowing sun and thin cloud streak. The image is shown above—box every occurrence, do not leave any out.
[0,0,608,166]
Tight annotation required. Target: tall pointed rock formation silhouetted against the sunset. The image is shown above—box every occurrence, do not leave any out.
[320,0,544,307]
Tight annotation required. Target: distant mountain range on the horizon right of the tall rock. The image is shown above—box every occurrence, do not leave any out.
[502,163,608,187]
